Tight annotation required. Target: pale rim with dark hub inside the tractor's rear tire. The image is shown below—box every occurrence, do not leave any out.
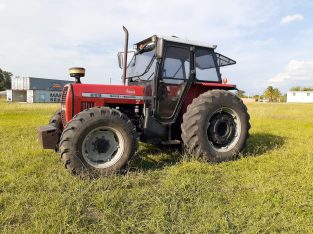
[207,108,241,152]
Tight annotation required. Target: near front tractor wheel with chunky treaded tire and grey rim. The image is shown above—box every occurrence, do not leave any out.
[60,107,137,176]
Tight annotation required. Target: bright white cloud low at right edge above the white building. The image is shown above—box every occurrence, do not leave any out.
[269,60,313,83]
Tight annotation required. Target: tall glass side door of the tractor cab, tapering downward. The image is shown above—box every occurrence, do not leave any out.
[156,45,193,122]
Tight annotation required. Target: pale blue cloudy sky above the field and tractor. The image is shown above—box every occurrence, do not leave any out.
[0,0,313,95]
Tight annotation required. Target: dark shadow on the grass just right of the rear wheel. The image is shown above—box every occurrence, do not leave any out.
[242,133,285,157]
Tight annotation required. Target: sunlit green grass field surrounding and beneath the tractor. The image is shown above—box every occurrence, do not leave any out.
[0,101,313,233]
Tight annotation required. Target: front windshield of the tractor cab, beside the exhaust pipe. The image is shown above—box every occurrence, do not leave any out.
[126,50,156,80]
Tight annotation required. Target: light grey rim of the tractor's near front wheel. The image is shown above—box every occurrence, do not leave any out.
[82,127,124,168]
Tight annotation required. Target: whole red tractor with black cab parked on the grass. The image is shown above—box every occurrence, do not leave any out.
[39,27,250,175]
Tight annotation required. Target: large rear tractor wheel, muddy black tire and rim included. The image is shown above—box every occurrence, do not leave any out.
[181,90,250,162]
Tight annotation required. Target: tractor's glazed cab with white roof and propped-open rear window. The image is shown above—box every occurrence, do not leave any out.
[118,35,236,123]
